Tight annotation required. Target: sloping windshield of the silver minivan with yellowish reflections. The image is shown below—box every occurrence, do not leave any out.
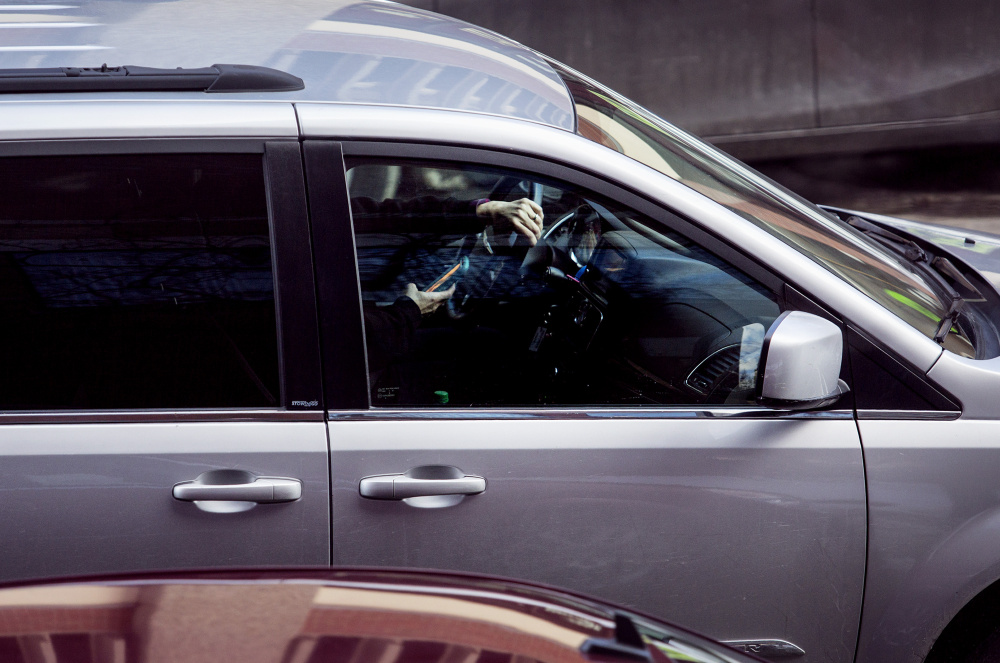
[549,60,971,355]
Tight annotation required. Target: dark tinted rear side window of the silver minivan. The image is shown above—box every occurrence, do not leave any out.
[0,154,279,410]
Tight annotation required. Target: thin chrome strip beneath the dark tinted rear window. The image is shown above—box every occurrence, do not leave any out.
[0,408,324,426]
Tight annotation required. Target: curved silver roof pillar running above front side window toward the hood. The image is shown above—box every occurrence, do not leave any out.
[295,103,942,372]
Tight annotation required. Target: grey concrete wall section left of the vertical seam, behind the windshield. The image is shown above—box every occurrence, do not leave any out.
[406,0,815,134]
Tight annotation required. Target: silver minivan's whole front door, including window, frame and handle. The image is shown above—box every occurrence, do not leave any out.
[305,141,865,661]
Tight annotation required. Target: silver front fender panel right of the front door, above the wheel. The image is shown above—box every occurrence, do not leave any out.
[858,422,1000,663]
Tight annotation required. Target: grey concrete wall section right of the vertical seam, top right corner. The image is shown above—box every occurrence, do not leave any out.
[816,0,1000,126]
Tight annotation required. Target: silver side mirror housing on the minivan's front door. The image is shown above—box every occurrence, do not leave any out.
[757,311,848,410]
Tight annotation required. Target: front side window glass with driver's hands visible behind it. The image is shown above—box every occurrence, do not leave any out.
[347,158,780,407]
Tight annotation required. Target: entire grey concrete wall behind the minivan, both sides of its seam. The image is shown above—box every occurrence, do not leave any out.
[405,0,1000,148]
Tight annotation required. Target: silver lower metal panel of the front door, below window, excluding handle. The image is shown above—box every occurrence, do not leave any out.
[330,418,865,661]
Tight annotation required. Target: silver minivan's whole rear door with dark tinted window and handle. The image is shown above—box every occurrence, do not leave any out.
[0,139,329,581]
